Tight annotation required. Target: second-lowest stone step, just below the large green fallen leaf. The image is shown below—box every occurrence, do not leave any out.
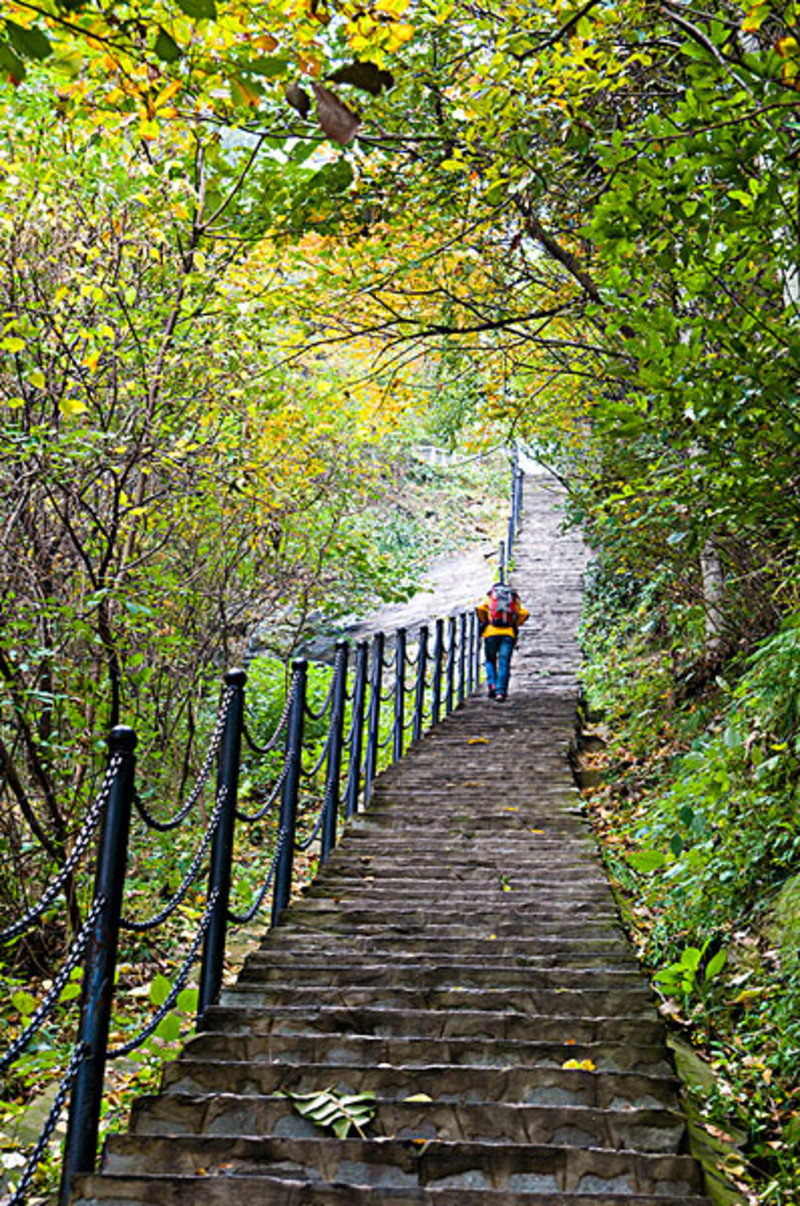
[105,1135,700,1194]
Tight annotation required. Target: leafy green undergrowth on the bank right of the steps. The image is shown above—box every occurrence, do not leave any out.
[583,573,800,1206]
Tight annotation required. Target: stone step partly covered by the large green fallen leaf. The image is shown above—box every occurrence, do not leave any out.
[130,1093,685,1153]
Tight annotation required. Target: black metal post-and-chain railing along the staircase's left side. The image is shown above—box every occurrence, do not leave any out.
[0,451,524,1206]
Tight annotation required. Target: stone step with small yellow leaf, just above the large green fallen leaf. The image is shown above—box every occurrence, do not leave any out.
[164,1055,677,1110]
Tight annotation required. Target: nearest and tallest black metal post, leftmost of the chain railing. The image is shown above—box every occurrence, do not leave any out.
[59,725,136,1206]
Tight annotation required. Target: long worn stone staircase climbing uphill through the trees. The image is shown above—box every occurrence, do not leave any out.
[74,479,706,1206]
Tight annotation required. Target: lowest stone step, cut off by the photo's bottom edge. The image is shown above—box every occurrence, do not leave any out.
[72,1172,710,1206]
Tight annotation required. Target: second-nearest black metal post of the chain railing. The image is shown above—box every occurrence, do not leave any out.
[197,669,247,1030]
